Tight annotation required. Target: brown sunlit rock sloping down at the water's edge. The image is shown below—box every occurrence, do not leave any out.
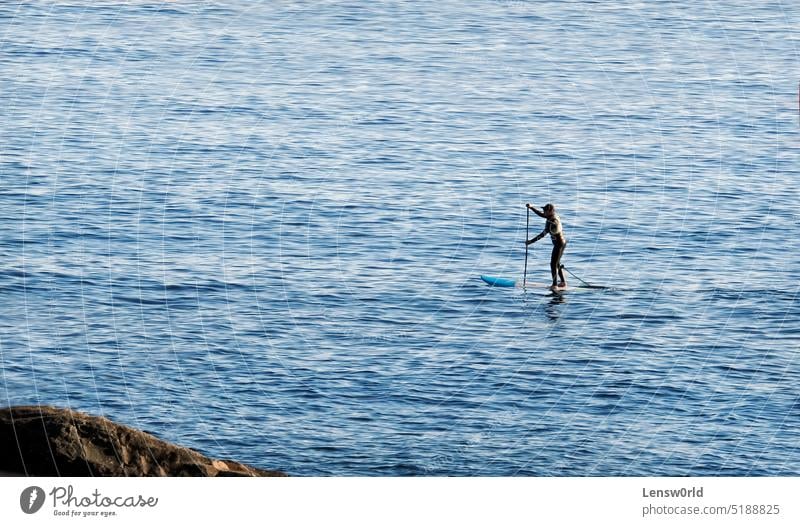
[0,406,286,477]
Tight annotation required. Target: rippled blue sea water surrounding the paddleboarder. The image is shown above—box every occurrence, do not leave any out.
[0,0,800,476]
